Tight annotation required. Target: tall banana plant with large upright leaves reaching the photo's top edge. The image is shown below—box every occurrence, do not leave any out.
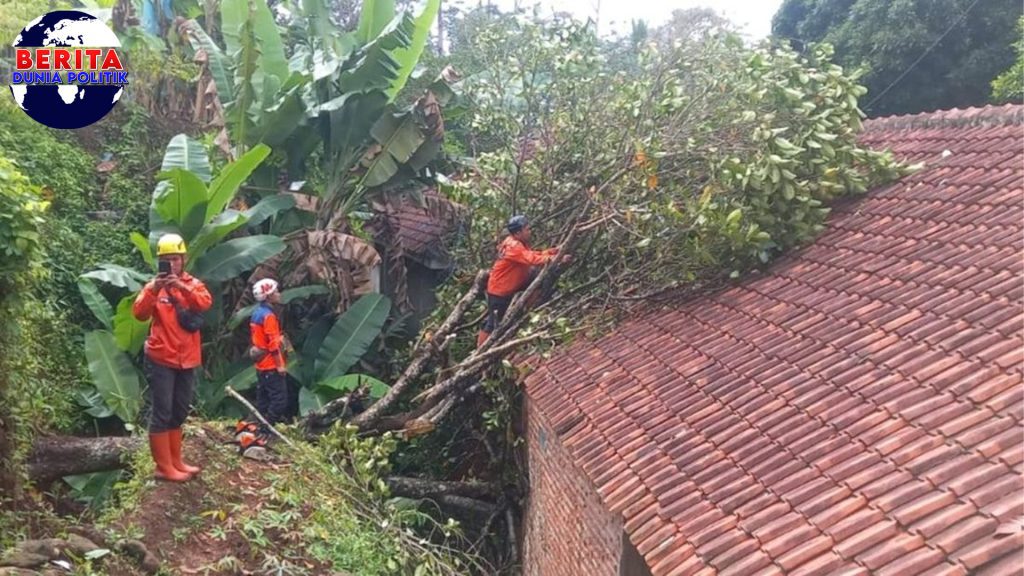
[181,0,448,199]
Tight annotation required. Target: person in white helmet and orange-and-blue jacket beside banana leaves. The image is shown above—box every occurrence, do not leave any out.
[249,278,290,435]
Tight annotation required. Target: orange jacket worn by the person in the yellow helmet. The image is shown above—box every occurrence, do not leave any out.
[131,273,213,370]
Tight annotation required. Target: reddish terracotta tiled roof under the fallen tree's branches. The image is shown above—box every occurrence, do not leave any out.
[526,107,1024,576]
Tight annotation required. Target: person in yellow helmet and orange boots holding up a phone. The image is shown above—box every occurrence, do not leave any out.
[132,234,213,482]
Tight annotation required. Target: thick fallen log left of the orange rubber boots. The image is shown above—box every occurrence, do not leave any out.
[28,436,142,486]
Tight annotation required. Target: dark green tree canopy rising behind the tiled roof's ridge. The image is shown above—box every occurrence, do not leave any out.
[772,0,1022,116]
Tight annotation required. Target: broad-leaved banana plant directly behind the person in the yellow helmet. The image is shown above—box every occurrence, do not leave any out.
[79,134,294,423]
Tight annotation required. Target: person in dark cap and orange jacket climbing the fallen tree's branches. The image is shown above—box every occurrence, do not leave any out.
[476,214,569,347]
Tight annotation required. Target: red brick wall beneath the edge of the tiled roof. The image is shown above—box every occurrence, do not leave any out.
[523,398,623,576]
